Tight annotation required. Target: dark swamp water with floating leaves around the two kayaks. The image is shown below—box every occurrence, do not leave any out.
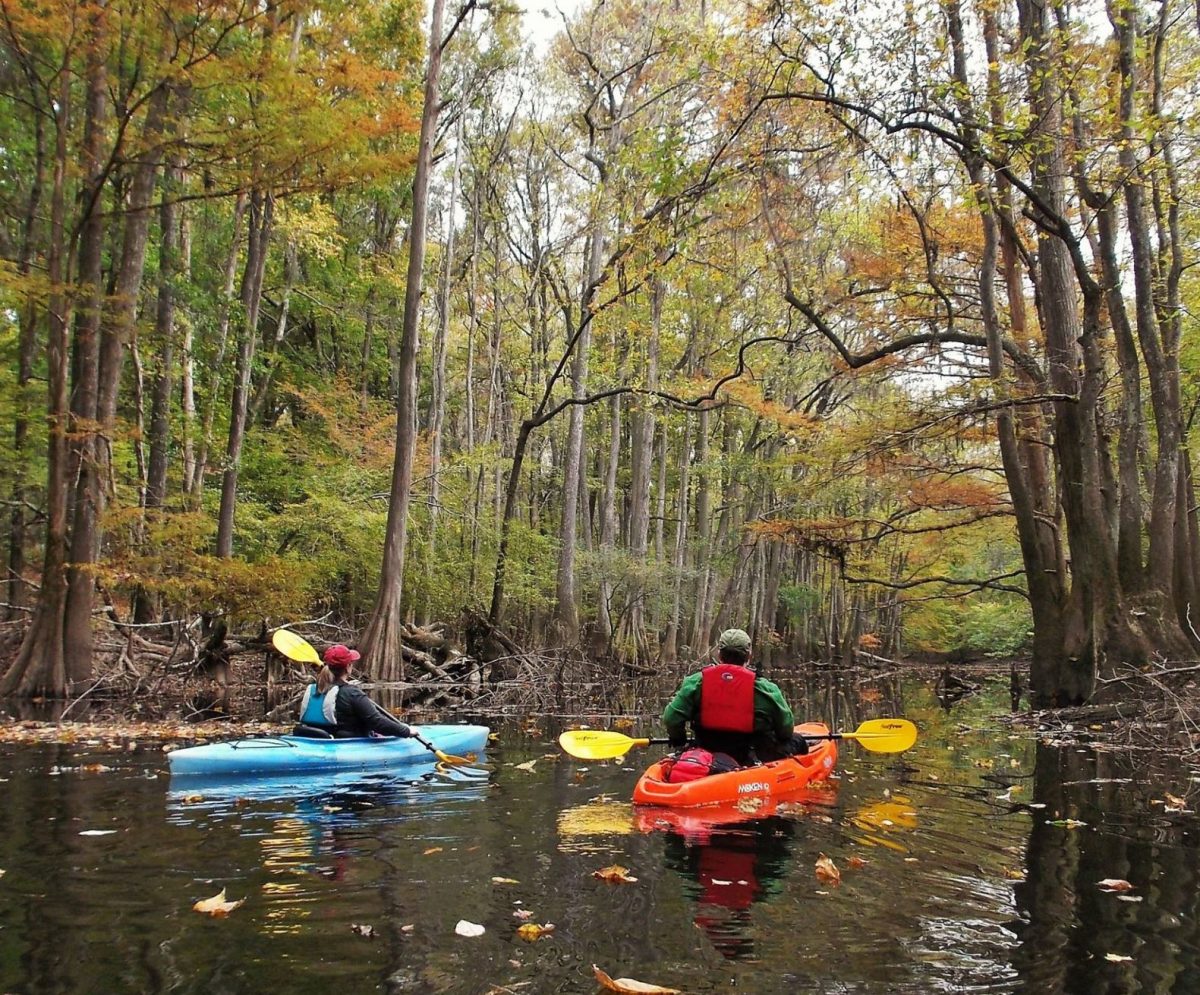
[0,678,1200,995]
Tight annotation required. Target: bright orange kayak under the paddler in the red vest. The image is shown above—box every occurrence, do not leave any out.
[634,723,838,810]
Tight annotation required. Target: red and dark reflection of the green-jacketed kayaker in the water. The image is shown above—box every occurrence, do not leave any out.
[666,820,792,960]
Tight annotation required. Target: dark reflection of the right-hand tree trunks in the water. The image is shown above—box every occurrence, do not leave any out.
[1014,743,1200,995]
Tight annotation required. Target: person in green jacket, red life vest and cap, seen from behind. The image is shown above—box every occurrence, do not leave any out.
[662,629,808,765]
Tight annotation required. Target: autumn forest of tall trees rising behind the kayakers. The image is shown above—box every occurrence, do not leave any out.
[0,0,1200,705]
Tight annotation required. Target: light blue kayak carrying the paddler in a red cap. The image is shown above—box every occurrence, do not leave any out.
[167,725,488,777]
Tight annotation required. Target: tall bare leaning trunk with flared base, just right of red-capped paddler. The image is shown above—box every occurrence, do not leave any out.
[362,0,445,681]
